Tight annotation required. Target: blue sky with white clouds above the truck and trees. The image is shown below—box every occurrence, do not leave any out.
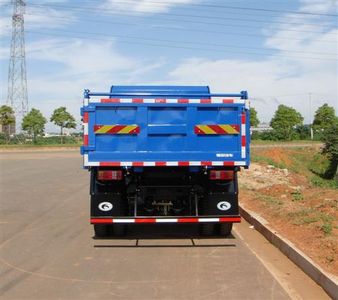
[0,0,338,131]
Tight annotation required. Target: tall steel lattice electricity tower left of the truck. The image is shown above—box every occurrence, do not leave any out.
[7,0,28,128]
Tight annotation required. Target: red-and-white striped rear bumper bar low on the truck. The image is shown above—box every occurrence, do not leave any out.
[90,216,241,224]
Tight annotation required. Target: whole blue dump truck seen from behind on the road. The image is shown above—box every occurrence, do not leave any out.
[81,86,250,237]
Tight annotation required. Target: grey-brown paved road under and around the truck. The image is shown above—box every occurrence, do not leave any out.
[0,152,327,299]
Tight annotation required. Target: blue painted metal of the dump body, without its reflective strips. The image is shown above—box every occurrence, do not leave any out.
[82,86,250,166]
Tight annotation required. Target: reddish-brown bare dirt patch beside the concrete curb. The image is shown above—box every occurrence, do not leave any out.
[239,163,338,275]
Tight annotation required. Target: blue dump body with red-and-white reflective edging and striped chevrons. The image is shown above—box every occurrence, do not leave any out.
[82,86,250,167]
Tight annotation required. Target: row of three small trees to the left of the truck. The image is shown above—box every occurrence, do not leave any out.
[0,105,76,143]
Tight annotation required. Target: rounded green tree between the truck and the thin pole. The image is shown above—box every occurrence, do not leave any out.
[270,105,303,140]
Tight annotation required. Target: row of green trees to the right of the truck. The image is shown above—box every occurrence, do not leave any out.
[250,104,338,140]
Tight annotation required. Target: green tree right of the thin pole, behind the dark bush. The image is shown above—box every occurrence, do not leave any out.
[312,103,336,138]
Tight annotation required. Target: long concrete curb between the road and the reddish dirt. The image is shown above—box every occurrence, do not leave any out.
[240,206,338,299]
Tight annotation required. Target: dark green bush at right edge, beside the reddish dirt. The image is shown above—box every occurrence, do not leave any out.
[322,117,338,183]
